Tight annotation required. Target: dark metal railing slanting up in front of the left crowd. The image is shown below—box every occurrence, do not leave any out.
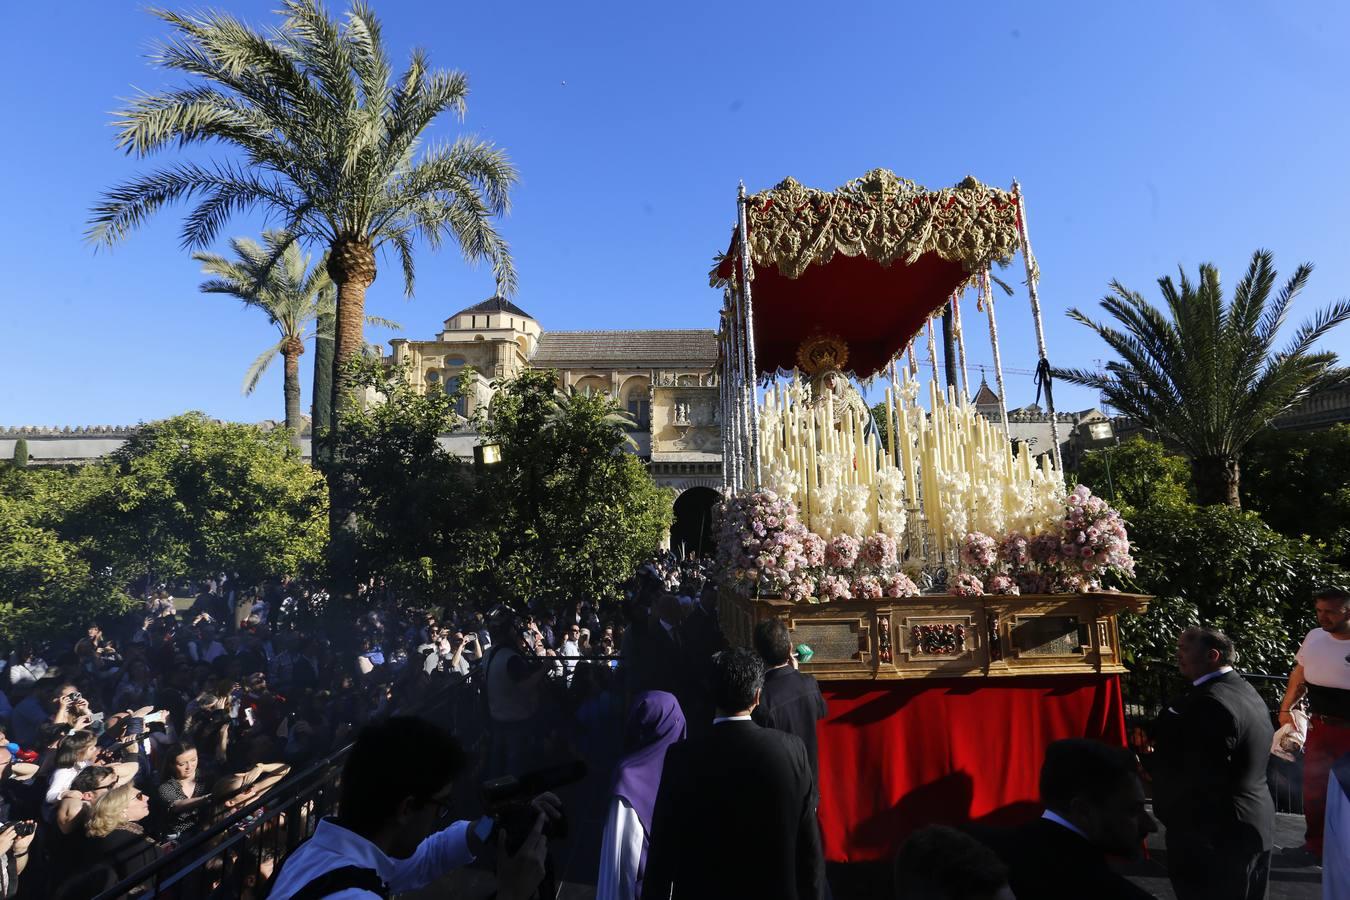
[95,677,479,900]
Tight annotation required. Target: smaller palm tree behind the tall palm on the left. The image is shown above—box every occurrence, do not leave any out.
[192,231,398,449]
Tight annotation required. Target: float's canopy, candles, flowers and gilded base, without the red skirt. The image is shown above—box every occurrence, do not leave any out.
[711,170,1146,679]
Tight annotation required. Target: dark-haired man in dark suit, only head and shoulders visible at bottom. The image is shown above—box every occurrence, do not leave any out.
[976,738,1157,900]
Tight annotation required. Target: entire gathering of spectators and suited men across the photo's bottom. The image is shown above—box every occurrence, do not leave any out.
[0,555,1350,900]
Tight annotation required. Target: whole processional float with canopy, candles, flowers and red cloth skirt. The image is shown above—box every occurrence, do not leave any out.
[711,170,1148,862]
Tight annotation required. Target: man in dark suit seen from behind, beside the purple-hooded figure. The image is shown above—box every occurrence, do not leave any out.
[643,648,825,900]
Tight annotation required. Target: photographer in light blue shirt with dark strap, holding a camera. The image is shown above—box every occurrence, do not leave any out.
[270,716,560,900]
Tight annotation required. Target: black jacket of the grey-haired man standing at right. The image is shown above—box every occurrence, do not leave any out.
[1149,672,1274,853]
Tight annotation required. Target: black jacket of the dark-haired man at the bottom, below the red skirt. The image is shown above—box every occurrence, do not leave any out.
[975,819,1153,900]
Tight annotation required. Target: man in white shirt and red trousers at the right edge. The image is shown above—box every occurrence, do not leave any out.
[1280,588,1350,857]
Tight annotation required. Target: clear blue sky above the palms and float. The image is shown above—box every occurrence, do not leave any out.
[0,0,1350,425]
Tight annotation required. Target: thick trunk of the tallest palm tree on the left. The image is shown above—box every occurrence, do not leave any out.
[324,235,375,598]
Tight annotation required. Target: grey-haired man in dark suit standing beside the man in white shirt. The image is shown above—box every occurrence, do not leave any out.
[1150,627,1274,900]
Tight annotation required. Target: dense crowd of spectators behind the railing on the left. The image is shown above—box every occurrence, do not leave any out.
[0,553,706,899]
